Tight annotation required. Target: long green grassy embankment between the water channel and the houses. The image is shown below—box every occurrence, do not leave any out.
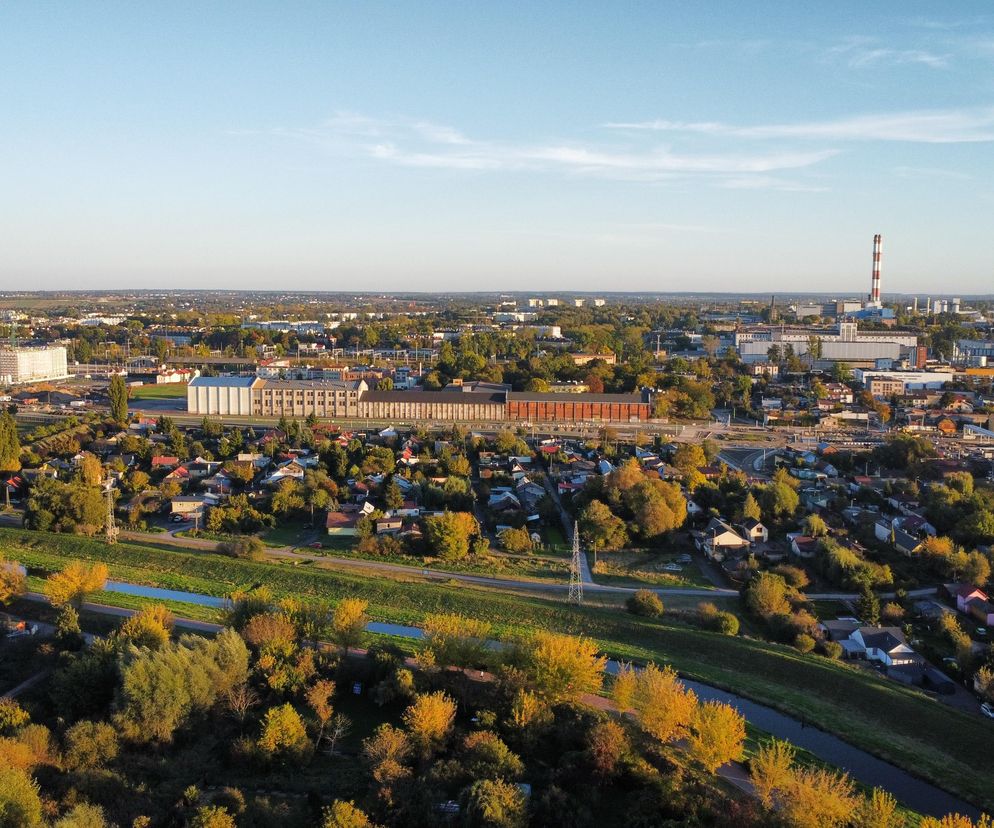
[0,529,994,808]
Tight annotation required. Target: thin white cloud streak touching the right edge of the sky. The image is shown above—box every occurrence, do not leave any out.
[604,107,994,144]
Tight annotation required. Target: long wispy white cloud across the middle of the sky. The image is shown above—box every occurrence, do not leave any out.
[266,112,837,181]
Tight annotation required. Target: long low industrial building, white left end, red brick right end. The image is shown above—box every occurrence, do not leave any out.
[187,377,652,423]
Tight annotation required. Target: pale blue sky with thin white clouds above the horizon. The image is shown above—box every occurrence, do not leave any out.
[0,0,994,299]
